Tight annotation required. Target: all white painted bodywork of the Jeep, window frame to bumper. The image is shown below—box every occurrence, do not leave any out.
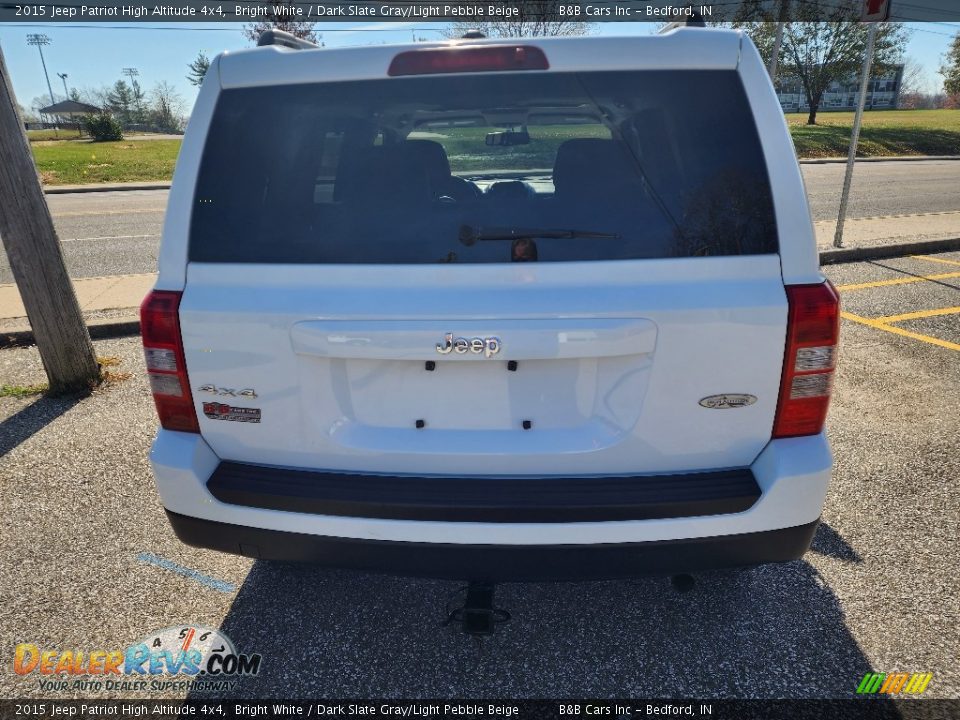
[150,29,832,564]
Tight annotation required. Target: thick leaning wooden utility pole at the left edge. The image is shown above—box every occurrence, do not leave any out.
[0,46,100,394]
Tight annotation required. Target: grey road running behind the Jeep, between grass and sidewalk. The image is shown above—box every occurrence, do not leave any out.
[0,161,960,283]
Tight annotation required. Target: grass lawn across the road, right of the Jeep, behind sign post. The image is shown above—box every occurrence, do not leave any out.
[787,110,960,158]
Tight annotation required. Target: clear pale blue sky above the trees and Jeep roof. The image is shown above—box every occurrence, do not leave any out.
[0,22,960,114]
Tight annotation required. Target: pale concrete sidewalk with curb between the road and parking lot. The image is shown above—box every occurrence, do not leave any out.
[0,212,960,347]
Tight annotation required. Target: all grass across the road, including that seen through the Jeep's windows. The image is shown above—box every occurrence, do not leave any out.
[31,110,960,185]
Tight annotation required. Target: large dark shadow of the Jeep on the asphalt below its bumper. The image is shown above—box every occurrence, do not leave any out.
[196,561,870,698]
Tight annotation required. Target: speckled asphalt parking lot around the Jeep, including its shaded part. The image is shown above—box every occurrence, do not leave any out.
[0,253,960,698]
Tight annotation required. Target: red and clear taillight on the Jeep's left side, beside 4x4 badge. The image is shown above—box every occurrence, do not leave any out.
[140,290,200,433]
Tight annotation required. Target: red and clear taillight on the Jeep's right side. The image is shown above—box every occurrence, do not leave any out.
[773,280,840,438]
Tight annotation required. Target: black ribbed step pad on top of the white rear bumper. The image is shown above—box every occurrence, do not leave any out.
[207,462,760,523]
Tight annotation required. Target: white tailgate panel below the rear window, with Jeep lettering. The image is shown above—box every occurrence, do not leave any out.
[180,256,787,475]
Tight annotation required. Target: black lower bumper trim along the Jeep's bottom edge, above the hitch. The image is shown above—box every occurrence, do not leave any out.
[167,510,820,582]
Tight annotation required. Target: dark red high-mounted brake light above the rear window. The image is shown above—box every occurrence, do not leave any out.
[387,45,550,77]
